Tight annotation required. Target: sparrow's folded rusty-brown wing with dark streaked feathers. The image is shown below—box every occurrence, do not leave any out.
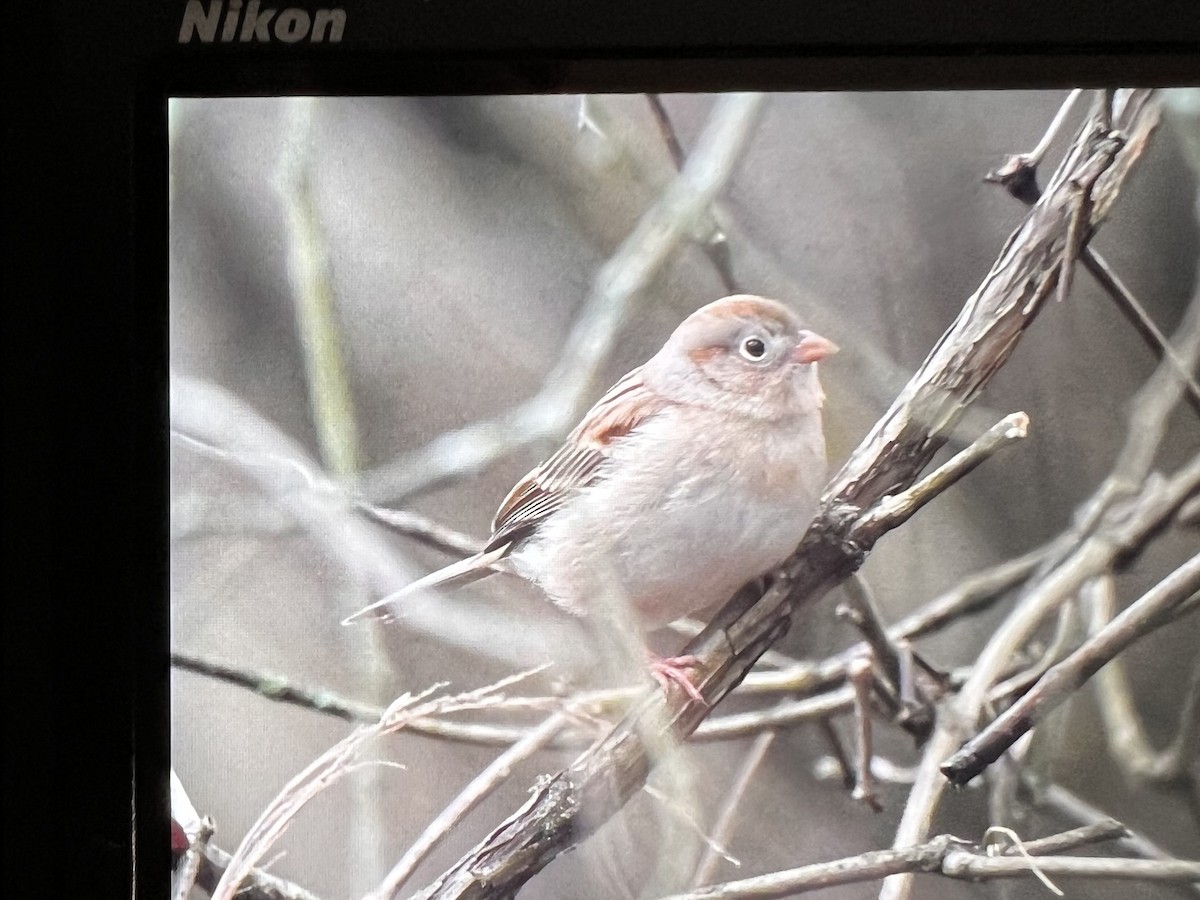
[485,366,666,552]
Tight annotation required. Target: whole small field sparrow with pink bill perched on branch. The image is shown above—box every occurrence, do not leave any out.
[347,294,838,696]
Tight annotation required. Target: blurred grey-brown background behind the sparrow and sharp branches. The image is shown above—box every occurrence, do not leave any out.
[169,91,1200,898]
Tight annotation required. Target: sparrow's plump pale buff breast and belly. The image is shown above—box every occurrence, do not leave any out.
[515,410,824,625]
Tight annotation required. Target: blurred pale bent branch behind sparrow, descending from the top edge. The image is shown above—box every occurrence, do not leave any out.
[364,94,763,508]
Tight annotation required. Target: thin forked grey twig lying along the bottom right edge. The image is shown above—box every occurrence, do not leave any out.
[664,820,1147,900]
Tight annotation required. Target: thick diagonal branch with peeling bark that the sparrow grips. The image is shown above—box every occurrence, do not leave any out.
[422,91,1158,898]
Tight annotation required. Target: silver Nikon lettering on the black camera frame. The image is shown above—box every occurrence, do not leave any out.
[179,0,346,43]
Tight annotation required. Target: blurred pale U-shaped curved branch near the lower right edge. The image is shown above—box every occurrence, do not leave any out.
[1084,575,1200,782]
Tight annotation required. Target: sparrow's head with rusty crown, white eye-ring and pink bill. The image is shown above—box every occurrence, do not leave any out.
[646,294,838,419]
